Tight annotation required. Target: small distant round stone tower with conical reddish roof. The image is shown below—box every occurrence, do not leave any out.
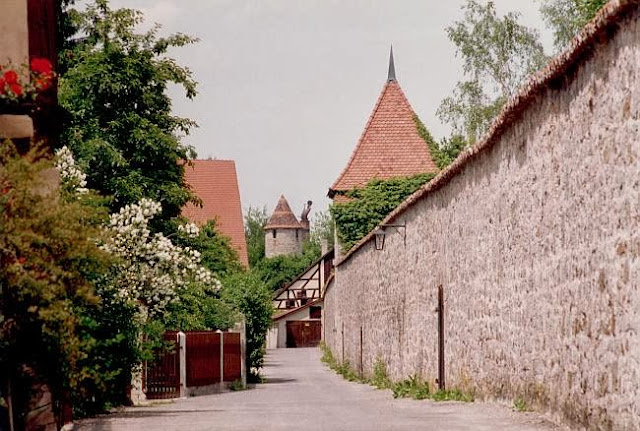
[264,196,311,257]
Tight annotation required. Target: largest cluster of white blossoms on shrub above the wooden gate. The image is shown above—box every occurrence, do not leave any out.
[102,199,220,314]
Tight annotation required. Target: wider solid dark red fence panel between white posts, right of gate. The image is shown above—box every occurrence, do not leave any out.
[186,331,220,387]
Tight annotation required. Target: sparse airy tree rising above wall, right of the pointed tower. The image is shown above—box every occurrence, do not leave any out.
[438,0,547,144]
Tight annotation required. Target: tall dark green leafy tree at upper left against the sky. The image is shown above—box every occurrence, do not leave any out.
[59,0,196,227]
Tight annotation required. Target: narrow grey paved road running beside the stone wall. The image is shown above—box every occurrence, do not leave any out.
[78,349,564,431]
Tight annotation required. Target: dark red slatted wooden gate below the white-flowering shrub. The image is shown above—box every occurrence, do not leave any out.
[143,331,180,400]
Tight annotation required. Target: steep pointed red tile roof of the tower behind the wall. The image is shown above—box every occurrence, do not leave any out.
[329,80,438,197]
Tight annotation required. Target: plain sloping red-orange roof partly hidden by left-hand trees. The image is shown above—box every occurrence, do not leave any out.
[182,160,249,266]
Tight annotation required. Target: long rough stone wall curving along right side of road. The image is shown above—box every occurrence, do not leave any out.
[324,2,640,430]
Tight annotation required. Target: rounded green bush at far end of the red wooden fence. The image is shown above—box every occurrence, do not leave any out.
[222,272,273,380]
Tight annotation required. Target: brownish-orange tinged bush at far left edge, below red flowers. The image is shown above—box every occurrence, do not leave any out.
[0,141,109,429]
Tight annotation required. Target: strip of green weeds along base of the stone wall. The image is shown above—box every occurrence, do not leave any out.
[320,342,474,402]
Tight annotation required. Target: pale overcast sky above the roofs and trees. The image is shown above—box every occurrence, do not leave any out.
[107,0,552,221]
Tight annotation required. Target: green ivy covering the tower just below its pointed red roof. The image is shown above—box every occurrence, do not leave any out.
[331,173,435,250]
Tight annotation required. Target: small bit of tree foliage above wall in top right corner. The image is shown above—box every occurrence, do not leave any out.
[540,0,608,51]
